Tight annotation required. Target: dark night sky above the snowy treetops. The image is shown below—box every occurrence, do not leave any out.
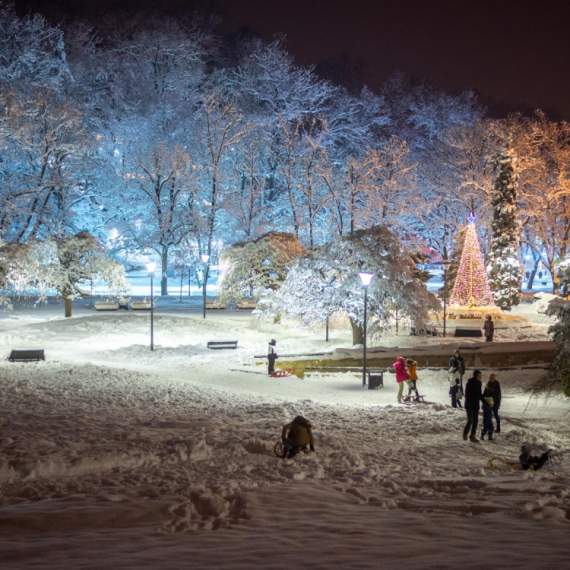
[12,0,570,120]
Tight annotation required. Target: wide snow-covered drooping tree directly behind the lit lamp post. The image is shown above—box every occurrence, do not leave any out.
[255,226,440,344]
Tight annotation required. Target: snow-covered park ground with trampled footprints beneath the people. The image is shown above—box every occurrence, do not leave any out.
[0,297,570,570]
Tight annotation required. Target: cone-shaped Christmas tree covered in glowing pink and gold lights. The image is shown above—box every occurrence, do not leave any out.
[450,212,495,307]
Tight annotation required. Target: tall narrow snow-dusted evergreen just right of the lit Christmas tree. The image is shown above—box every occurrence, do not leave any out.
[487,140,522,309]
